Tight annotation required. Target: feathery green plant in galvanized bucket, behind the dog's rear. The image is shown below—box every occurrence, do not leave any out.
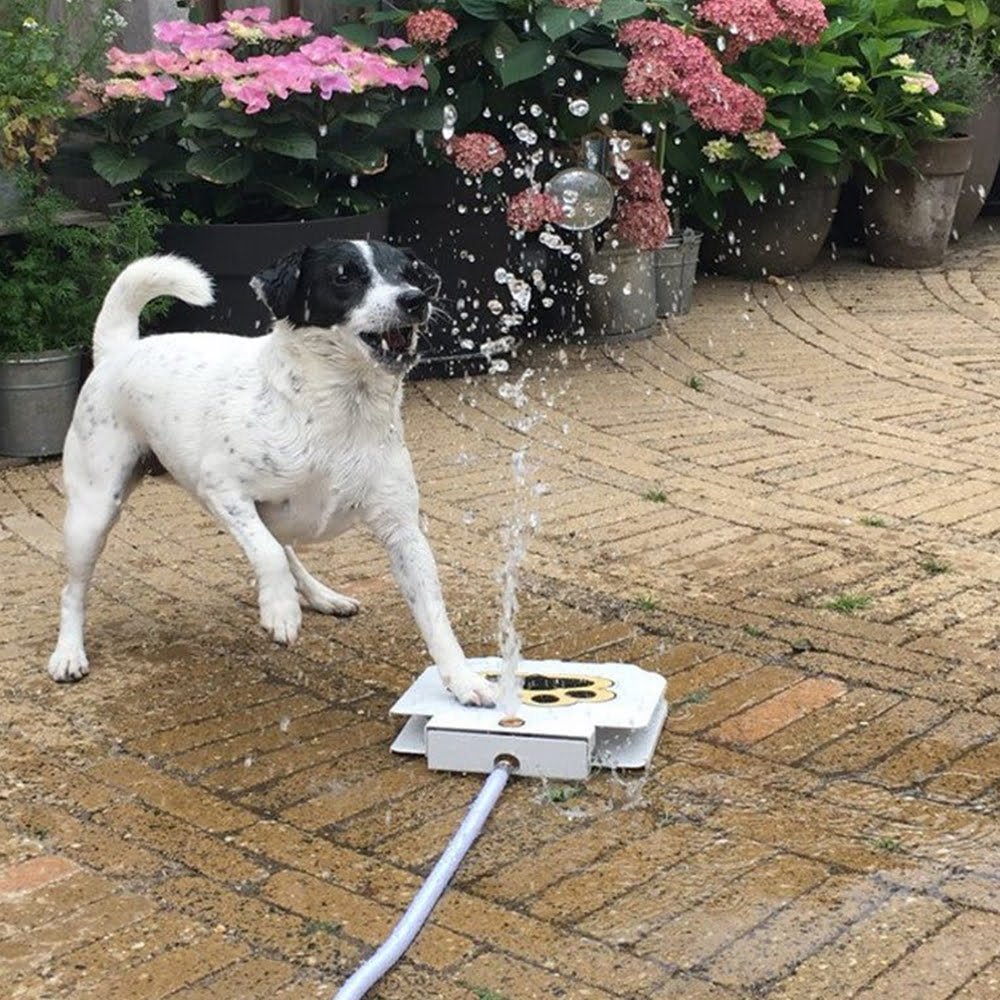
[0,176,162,458]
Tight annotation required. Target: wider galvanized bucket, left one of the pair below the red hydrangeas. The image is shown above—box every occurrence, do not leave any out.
[583,240,656,337]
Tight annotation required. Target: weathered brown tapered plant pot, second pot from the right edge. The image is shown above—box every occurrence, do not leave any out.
[862,136,974,268]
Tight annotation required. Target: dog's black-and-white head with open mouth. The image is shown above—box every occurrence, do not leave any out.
[250,240,441,368]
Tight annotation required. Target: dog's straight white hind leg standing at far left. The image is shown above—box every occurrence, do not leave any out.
[49,427,140,681]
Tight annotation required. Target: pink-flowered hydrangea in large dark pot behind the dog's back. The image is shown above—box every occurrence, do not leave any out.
[70,7,427,334]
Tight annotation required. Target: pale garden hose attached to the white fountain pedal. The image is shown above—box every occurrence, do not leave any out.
[333,761,511,1000]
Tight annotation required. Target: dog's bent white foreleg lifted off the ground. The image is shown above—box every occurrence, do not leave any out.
[199,489,302,646]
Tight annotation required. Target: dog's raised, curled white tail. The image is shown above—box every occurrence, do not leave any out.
[94,254,215,364]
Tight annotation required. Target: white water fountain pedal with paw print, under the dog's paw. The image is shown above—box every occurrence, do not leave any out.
[391,657,667,780]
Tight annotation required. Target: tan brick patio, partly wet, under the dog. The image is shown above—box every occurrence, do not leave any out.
[0,226,1000,1000]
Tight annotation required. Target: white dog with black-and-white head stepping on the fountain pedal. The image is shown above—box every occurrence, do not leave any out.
[49,240,495,705]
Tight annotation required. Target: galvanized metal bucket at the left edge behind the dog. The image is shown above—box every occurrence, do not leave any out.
[0,347,80,458]
